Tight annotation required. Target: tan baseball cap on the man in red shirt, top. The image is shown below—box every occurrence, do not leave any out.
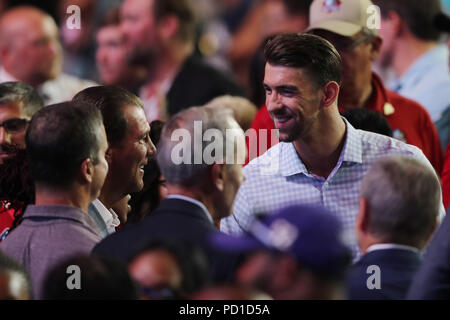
[306,0,378,37]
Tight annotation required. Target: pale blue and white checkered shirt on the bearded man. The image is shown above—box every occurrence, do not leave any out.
[220,119,445,258]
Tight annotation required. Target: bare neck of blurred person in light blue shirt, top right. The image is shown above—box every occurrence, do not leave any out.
[392,36,437,78]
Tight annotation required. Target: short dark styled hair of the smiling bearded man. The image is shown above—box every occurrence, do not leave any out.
[264,33,342,87]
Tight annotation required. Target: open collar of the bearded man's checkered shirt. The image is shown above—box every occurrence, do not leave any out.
[279,118,362,177]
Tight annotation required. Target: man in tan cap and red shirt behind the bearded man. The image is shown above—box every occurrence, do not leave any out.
[250,0,442,174]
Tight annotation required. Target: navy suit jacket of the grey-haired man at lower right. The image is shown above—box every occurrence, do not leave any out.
[347,248,422,300]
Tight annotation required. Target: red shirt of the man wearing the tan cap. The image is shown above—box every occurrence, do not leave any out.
[252,73,443,173]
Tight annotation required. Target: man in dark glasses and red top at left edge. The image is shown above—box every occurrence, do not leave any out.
[0,82,44,241]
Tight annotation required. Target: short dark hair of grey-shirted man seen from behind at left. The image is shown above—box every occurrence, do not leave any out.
[25,102,103,188]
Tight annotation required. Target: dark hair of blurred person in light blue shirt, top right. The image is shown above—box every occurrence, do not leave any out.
[373,0,442,41]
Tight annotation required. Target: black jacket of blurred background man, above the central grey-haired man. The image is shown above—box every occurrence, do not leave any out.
[167,56,245,116]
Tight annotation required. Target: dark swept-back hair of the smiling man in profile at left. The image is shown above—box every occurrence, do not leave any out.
[73,86,144,146]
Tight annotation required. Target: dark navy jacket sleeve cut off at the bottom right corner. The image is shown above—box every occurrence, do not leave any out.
[407,211,450,300]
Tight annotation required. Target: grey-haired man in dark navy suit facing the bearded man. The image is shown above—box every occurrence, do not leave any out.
[93,107,245,281]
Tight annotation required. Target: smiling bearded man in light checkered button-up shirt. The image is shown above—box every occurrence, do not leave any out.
[221,33,444,256]
